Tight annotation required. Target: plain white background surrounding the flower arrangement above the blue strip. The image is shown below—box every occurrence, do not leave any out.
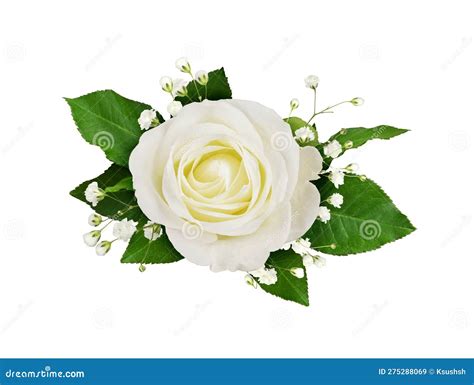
[0,0,474,357]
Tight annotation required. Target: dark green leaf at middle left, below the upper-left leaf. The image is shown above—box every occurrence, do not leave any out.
[70,164,143,221]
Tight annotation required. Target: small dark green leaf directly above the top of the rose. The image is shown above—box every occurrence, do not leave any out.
[175,68,232,106]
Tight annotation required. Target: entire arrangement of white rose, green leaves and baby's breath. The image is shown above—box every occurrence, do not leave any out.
[66,58,415,306]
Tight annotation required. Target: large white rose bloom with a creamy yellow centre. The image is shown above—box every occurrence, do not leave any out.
[129,99,322,271]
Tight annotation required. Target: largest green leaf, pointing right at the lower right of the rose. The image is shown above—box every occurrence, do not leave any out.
[304,174,415,255]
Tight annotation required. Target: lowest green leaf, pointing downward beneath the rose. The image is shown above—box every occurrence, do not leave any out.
[259,249,309,306]
